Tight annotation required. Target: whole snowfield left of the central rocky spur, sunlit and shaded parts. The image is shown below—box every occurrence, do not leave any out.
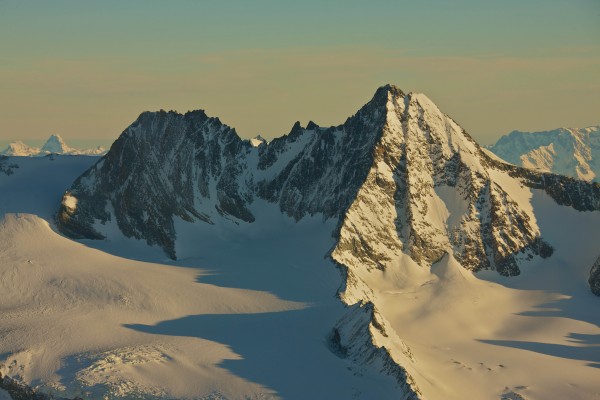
[0,157,404,399]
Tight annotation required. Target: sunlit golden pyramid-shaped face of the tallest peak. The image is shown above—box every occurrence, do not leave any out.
[333,86,550,280]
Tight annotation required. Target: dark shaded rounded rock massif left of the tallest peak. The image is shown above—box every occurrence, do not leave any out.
[57,111,254,258]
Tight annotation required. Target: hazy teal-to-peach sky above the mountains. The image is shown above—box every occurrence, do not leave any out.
[0,0,600,146]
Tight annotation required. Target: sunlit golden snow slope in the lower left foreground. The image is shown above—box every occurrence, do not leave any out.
[0,214,302,398]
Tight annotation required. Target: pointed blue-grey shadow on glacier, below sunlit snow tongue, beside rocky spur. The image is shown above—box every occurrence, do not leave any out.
[126,306,394,399]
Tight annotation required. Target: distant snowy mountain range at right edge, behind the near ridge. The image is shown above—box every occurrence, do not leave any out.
[488,126,600,181]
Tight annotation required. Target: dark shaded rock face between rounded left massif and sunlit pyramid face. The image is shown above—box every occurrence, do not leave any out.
[256,89,387,220]
